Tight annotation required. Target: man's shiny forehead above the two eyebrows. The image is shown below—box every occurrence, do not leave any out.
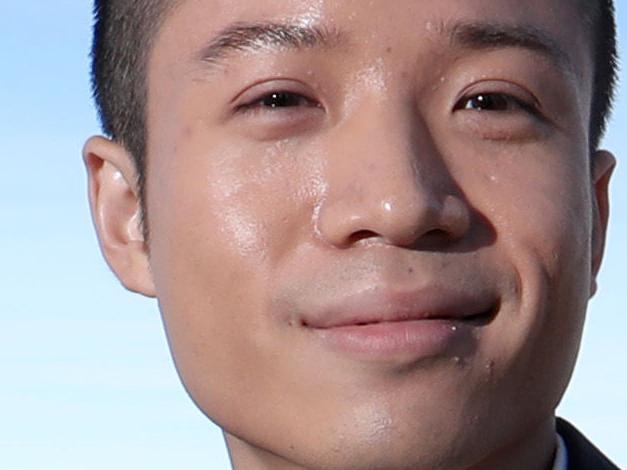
[152,0,594,70]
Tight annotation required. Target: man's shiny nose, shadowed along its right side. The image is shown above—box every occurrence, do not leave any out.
[315,103,471,249]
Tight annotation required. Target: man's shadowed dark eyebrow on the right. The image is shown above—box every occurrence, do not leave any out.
[442,23,576,75]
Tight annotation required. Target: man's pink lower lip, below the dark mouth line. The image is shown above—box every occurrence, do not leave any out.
[315,319,475,361]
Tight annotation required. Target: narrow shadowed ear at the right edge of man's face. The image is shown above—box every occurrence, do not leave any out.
[590,150,616,297]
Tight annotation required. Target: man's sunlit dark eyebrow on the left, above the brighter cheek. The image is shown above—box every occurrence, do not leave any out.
[199,22,345,65]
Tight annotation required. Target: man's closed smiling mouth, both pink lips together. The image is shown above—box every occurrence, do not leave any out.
[302,287,498,362]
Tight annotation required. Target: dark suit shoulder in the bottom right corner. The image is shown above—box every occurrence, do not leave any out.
[556,418,620,470]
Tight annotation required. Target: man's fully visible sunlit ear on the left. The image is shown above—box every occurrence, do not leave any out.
[83,137,155,297]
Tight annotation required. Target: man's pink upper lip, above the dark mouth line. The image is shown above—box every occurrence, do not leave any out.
[303,287,497,329]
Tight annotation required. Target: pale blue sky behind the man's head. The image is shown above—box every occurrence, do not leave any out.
[0,0,627,470]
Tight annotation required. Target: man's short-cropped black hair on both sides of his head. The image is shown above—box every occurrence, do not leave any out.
[92,0,618,221]
